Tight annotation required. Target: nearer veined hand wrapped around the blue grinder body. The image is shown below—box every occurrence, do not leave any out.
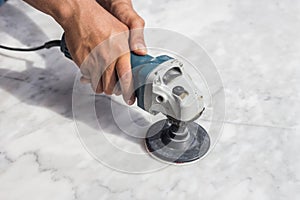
[60,0,135,105]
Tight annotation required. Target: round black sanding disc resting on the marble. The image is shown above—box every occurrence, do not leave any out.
[145,119,210,164]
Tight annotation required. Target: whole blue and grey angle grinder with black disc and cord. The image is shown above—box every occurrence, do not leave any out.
[0,35,210,164]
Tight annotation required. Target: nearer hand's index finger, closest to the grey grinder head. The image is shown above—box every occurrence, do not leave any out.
[116,53,135,105]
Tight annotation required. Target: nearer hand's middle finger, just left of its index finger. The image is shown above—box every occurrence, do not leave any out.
[102,62,117,95]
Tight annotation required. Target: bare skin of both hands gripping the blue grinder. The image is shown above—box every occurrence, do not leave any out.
[24,0,147,105]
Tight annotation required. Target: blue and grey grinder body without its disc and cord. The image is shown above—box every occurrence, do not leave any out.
[61,35,204,121]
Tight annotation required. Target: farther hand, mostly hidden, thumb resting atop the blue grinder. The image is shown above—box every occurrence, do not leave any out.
[97,0,147,55]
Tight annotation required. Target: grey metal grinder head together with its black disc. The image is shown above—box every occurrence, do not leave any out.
[140,59,210,164]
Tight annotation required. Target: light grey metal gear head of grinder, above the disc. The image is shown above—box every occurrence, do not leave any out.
[143,59,204,122]
